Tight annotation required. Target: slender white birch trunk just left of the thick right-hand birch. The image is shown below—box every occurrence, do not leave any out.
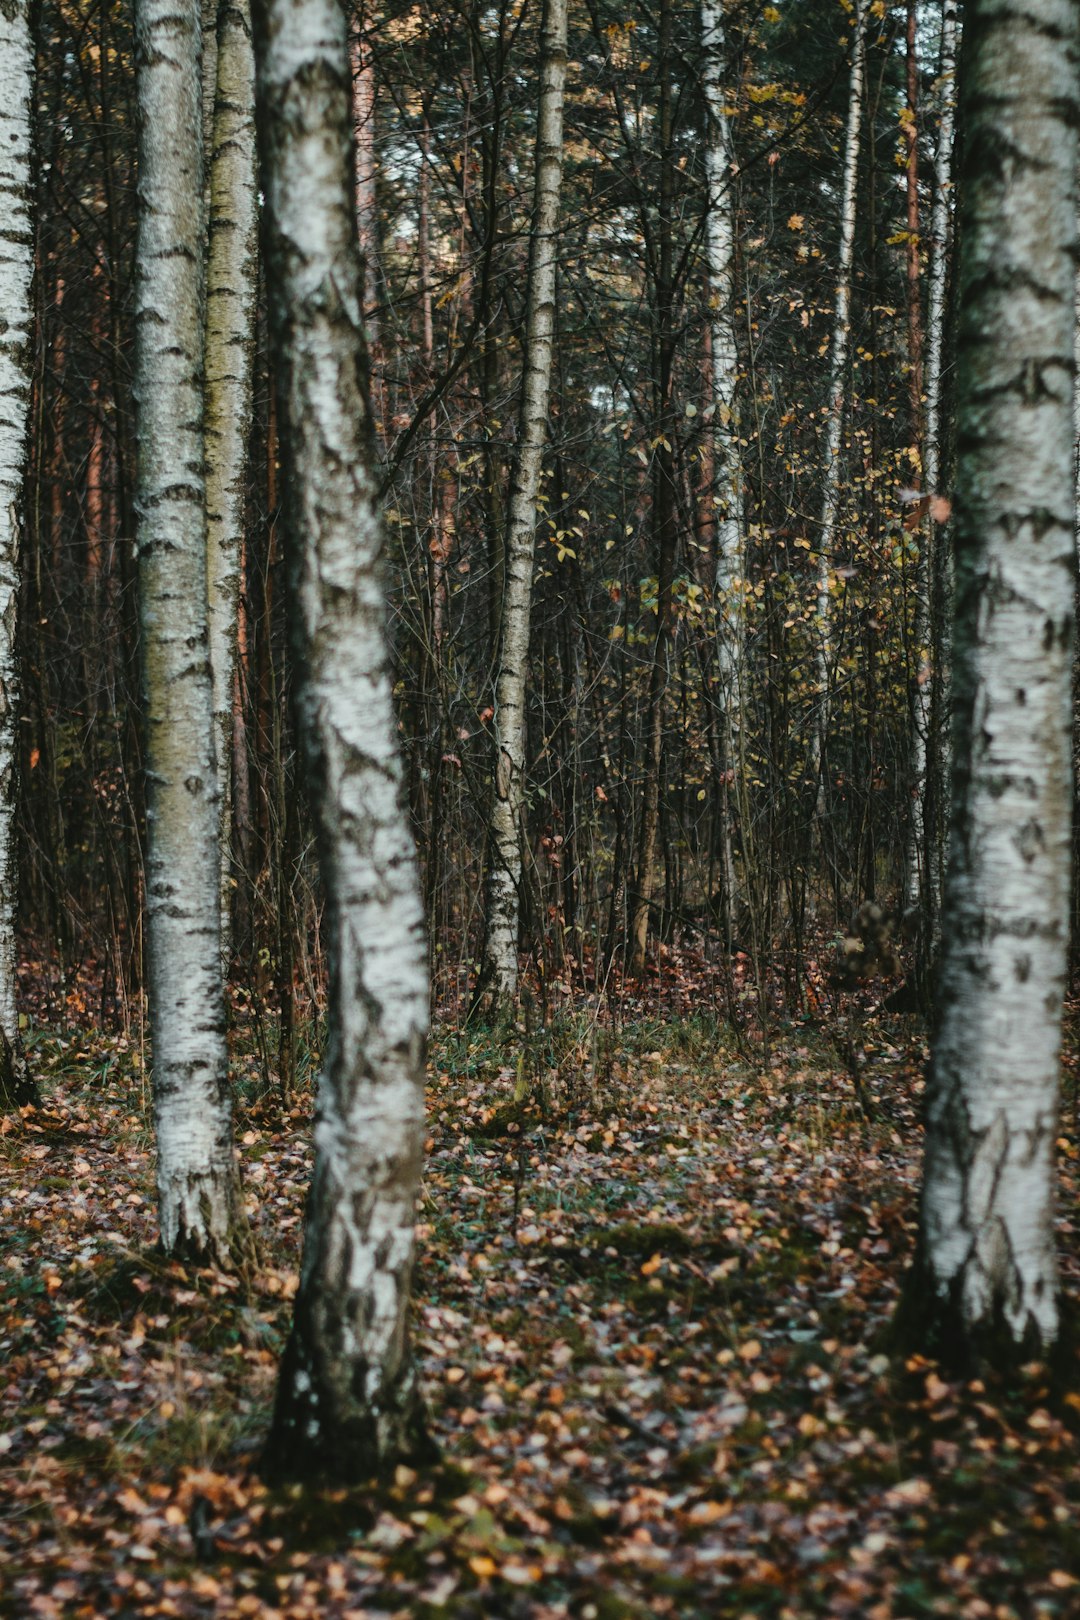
[904,0,959,917]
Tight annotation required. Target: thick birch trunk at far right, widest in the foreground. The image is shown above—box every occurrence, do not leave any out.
[908,0,1080,1362]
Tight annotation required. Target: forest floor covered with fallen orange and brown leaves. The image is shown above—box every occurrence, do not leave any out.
[0,959,1080,1620]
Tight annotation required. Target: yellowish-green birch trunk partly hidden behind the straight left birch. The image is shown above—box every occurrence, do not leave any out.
[204,0,257,961]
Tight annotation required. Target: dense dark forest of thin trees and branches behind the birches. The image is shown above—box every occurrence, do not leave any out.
[19,3,952,1036]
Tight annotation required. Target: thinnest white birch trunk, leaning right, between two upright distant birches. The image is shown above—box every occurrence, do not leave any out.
[810,0,868,797]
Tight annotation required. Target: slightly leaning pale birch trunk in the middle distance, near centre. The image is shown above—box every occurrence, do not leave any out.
[478,0,568,1013]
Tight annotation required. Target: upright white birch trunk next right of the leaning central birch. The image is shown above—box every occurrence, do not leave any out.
[701,0,745,949]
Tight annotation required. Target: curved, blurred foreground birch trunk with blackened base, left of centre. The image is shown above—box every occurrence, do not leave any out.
[254,0,427,1477]
